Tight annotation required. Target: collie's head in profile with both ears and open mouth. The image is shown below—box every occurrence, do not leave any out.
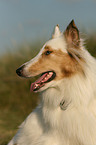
[16,20,82,92]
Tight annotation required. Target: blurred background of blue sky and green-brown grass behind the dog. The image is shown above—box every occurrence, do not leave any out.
[0,0,96,145]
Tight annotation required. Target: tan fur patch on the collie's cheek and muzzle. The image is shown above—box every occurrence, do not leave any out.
[28,46,82,80]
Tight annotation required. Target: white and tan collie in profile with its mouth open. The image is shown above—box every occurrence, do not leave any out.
[8,20,96,145]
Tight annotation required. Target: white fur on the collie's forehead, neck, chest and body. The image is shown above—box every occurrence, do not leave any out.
[8,27,96,145]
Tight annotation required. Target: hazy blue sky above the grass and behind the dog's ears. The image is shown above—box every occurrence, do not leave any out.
[0,0,96,53]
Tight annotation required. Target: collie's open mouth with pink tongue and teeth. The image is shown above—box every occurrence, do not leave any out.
[30,71,56,91]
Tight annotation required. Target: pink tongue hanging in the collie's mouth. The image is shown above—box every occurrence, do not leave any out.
[30,73,48,91]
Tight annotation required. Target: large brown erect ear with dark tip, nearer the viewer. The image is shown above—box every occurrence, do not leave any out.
[64,20,80,48]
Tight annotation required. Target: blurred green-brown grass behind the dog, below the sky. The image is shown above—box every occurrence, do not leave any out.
[0,36,96,145]
